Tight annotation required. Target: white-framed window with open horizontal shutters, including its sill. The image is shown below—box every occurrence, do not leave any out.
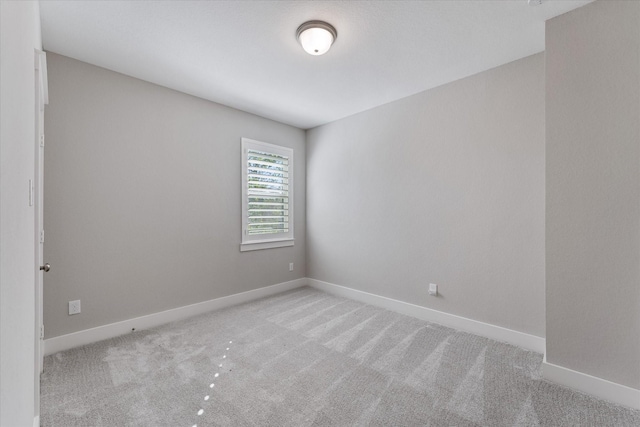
[240,138,293,251]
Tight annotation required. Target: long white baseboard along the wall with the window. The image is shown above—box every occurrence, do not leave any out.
[44,278,307,356]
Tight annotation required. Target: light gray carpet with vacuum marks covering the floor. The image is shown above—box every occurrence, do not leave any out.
[41,288,640,427]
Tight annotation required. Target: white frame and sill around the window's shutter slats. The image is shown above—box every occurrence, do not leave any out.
[240,138,295,252]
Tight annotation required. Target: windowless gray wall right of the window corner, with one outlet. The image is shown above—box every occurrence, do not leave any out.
[307,54,545,337]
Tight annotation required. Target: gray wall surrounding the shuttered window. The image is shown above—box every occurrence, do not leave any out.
[44,53,306,338]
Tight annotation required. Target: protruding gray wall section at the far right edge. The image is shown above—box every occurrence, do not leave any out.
[546,1,640,388]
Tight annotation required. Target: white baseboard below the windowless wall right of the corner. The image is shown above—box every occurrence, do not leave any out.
[307,279,545,353]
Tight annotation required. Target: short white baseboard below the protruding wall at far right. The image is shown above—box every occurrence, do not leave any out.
[542,354,640,409]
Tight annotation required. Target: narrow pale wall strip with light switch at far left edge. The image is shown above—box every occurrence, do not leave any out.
[0,1,41,426]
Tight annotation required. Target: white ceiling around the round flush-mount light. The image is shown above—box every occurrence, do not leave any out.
[40,0,591,129]
